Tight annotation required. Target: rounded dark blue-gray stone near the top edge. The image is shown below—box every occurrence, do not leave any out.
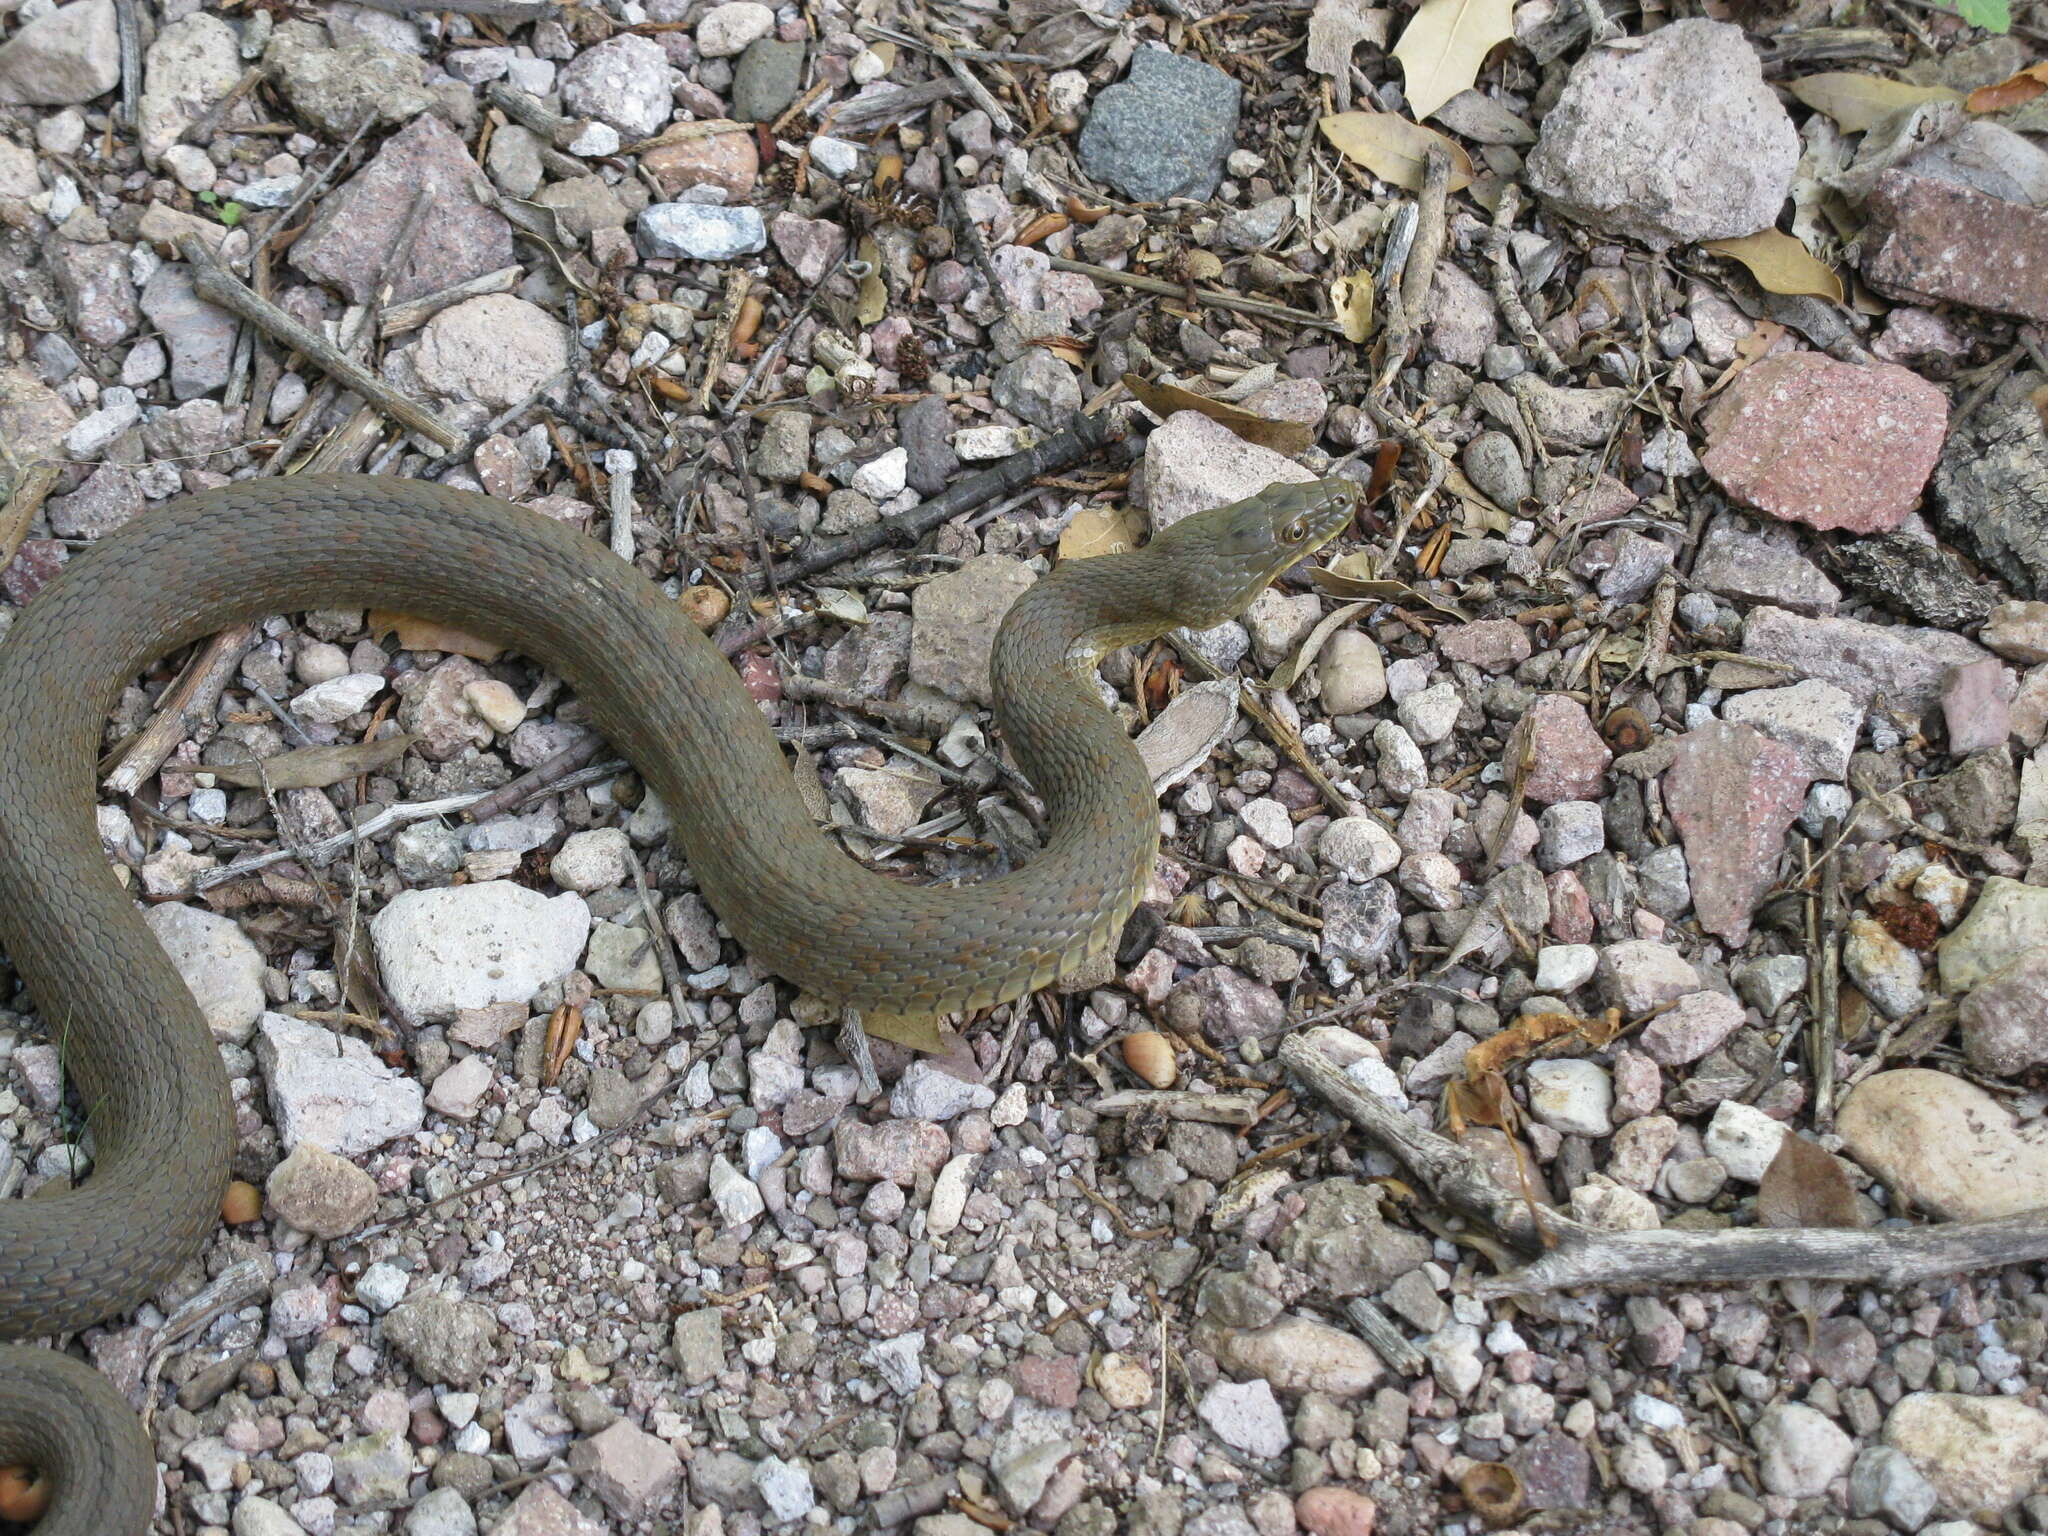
[1079,49,1243,203]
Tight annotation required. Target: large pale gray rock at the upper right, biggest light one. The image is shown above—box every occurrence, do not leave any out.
[1528,18,1800,250]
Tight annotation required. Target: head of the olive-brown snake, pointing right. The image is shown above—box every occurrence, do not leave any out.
[1147,479,1364,629]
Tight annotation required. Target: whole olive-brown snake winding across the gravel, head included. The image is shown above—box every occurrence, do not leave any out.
[0,475,1356,1536]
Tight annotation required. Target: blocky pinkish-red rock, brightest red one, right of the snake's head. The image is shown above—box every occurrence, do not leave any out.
[1700,352,1948,532]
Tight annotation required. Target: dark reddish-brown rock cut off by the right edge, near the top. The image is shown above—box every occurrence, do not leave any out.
[1864,170,2048,319]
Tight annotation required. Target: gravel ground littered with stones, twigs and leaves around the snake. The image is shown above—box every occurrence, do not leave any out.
[0,0,2048,1536]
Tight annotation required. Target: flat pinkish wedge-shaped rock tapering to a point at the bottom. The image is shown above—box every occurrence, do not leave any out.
[1663,721,1812,944]
